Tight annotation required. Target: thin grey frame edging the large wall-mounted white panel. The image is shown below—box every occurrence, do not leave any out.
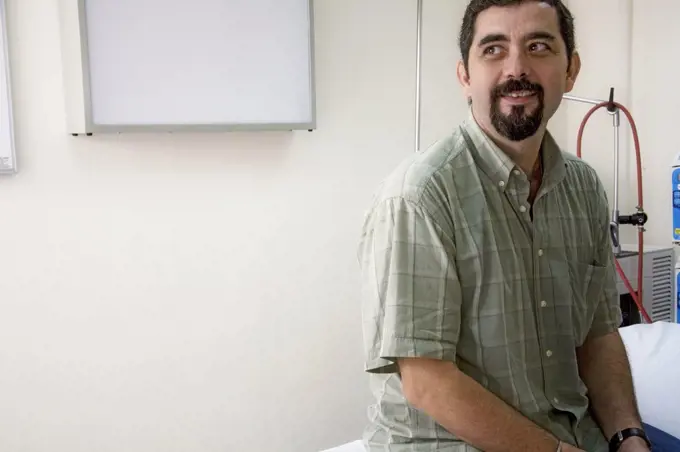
[73,0,317,135]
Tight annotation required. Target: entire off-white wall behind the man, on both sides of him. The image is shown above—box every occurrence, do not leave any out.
[0,0,675,452]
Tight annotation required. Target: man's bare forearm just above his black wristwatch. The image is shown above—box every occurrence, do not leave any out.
[577,331,642,439]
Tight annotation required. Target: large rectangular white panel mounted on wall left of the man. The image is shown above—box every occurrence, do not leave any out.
[73,0,315,130]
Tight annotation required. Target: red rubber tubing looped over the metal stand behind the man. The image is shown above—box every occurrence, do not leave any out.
[576,102,652,323]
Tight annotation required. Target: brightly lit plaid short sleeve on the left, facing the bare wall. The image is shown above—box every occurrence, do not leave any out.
[359,198,461,373]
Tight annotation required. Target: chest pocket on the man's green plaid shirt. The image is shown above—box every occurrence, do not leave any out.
[569,262,607,346]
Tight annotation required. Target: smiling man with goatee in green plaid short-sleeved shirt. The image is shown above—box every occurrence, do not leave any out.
[359,0,650,452]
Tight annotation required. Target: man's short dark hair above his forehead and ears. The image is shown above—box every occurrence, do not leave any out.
[458,0,576,74]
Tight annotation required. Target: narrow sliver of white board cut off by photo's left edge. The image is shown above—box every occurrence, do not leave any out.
[0,0,17,174]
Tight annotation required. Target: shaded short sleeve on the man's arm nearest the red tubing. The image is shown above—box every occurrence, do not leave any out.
[587,176,623,339]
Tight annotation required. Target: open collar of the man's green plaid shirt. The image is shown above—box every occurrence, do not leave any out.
[462,109,566,191]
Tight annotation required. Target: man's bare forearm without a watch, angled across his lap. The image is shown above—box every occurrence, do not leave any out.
[400,359,573,452]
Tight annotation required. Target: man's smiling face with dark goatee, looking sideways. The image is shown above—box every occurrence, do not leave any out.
[458,1,579,141]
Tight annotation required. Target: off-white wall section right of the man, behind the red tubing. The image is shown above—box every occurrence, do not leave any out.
[563,0,668,246]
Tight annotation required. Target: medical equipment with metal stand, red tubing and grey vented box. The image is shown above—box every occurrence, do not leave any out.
[563,88,678,325]
